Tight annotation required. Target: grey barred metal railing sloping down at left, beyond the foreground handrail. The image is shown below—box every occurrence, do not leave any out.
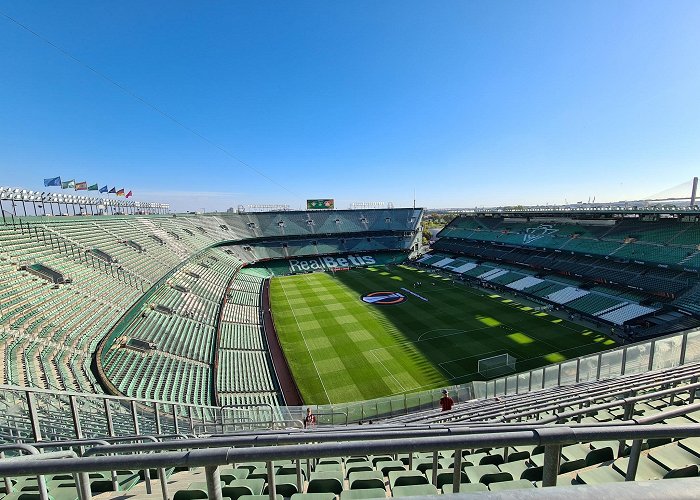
[0,385,290,443]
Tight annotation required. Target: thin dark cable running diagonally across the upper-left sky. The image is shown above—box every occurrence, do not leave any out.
[0,10,296,196]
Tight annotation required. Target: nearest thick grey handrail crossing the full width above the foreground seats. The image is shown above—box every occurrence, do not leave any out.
[0,425,700,494]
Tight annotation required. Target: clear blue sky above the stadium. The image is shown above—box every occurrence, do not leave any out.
[0,0,700,210]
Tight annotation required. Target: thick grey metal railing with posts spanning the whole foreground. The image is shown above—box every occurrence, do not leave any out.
[0,418,700,500]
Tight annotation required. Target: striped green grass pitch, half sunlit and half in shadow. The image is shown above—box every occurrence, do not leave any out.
[271,266,615,404]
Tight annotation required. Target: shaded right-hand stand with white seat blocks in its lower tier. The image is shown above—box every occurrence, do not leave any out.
[426,211,700,338]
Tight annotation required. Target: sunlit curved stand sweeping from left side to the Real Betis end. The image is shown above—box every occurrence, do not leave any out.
[0,209,422,405]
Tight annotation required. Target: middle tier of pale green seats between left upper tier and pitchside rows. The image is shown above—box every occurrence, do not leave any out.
[103,249,249,404]
